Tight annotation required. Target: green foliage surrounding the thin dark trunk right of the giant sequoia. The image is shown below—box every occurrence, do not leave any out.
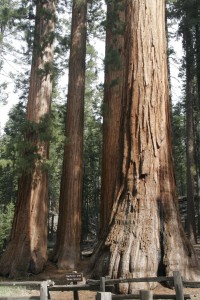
[168,0,200,199]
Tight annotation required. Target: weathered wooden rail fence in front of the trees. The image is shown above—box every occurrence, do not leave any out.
[0,271,200,300]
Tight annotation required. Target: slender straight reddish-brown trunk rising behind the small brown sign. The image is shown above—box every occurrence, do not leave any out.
[54,0,87,269]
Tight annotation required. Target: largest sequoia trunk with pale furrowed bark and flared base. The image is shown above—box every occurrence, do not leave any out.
[93,0,198,293]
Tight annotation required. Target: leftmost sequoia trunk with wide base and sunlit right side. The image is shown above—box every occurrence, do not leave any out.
[0,0,55,277]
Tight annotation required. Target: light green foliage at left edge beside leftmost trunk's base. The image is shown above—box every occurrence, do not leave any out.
[0,202,15,253]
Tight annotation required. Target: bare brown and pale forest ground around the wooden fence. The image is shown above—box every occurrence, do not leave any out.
[0,248,200,300]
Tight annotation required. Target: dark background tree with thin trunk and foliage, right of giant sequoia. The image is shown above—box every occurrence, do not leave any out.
[169,0,200,242]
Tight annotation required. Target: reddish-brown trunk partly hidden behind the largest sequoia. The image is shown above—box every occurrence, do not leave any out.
[100,0,125,233]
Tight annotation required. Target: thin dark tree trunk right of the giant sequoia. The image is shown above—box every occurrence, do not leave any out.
[183,21,197,243]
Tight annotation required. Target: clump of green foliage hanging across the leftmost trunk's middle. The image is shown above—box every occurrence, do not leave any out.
[0,103,53,175]
